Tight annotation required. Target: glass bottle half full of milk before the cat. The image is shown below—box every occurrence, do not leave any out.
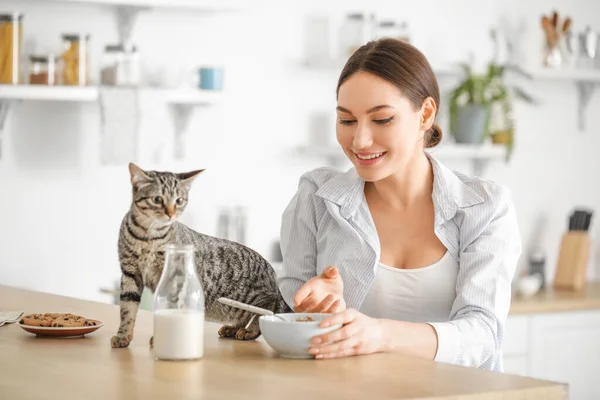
[154,244,204,360]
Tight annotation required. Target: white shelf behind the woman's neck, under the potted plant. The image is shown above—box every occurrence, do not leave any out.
[299,143,506,176]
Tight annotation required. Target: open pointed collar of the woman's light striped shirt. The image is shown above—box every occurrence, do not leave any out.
[316,154,484,225]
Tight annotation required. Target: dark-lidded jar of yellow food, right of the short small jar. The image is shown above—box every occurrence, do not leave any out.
[62,33,90,86]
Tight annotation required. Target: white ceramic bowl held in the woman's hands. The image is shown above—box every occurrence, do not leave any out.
[258,313,342,358]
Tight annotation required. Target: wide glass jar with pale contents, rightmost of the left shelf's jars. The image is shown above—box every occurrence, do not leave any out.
[100,44,141,86]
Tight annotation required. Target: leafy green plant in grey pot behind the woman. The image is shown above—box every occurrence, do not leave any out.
[450,63,533,159]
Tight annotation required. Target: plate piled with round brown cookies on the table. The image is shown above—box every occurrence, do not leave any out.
[18,313,104,337]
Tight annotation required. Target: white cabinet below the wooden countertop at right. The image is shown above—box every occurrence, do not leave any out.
[503,310,600,400]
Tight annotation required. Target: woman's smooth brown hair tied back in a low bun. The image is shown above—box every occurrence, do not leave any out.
[336,39,442,147]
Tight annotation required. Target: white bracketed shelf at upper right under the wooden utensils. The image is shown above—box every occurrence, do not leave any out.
[530,68,600,131]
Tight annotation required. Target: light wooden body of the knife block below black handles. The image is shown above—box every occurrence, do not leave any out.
[554,231,591,291]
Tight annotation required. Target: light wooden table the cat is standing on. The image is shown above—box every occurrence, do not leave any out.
[0,286,567,400]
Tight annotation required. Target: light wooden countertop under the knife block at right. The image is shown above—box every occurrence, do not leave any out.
[510,282,600,315]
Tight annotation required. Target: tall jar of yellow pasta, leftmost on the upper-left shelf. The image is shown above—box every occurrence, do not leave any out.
[0,13,23,85]
